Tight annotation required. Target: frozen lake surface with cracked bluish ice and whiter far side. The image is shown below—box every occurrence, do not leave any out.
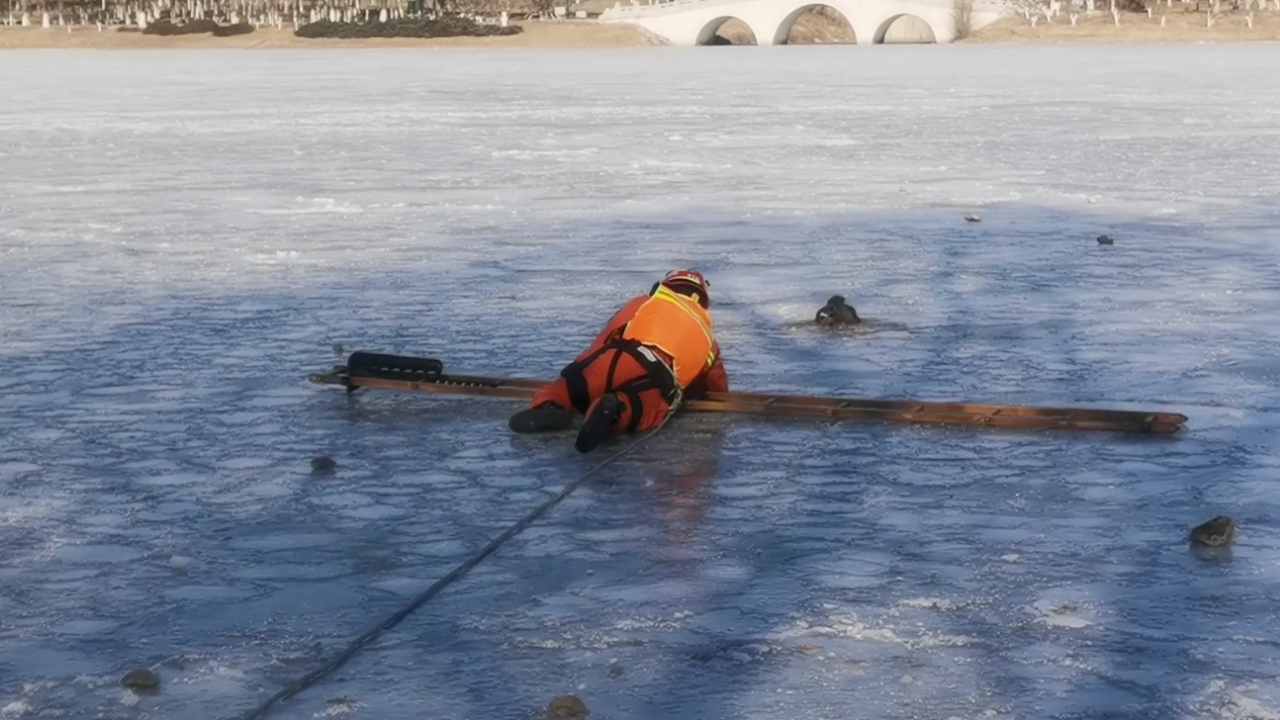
[0,45,1280,720]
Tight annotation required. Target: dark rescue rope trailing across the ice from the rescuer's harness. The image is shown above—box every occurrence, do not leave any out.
[229,389,681,720]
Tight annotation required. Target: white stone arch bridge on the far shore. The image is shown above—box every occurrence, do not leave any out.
[600,0,1010,45]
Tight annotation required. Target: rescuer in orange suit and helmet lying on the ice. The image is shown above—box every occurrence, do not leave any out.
[508,270,728,452]
